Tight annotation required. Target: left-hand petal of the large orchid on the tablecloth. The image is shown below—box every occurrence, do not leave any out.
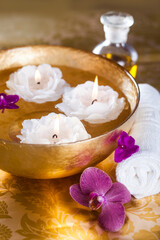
[70,184,89,207]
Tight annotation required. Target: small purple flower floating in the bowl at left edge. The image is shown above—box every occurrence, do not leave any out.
[0,93,19,113]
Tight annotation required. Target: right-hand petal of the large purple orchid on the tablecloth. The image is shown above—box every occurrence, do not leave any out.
[105,182,131,204]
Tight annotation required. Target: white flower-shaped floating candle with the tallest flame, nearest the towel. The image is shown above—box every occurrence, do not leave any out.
[56,77,125,123]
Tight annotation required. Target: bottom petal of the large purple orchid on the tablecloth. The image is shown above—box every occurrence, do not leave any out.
[98,202,125,232]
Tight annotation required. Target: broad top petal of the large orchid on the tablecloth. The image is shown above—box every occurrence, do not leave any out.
[80,167,112,195]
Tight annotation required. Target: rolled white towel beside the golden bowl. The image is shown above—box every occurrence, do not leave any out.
[116,84,160,198]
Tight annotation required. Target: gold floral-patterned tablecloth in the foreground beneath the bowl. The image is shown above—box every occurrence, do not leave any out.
[0,156,160,240]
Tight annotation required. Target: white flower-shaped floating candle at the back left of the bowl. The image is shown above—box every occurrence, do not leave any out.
[6,64,68,103]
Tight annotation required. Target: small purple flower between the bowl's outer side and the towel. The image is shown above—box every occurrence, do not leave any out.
[114,132,139,163]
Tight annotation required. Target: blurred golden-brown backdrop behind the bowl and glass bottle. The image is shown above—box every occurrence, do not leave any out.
[0,0,160,90]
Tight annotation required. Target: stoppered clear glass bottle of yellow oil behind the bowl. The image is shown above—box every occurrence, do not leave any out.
[93,12,138,77]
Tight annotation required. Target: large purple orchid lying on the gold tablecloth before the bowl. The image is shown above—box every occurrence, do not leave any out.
[70,167,131,232]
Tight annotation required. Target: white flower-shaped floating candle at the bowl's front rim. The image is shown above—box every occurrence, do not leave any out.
[17,113,91,144]
